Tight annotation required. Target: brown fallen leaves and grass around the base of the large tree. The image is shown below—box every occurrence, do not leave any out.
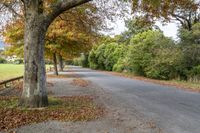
[0,96,104,131]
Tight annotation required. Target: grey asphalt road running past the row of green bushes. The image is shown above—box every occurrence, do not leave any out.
[71,67,200,133]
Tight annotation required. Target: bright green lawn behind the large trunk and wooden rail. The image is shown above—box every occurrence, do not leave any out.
[0,64,51,81]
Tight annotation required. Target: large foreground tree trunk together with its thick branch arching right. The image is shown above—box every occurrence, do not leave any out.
[19,0,90,107]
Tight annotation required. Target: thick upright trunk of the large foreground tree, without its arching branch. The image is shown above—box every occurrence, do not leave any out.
[19,1,48,107]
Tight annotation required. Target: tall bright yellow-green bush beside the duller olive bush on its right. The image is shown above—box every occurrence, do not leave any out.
[127,30,163,76]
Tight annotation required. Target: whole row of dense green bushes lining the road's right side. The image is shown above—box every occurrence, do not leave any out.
[89,21,200,81]
